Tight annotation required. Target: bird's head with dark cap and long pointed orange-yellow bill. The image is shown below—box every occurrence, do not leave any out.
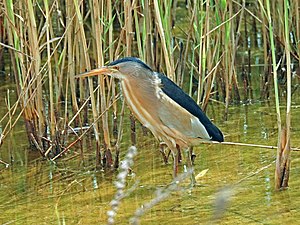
[75,57,153,79]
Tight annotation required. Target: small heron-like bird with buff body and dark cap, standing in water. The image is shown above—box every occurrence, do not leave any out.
[76,57,224,182]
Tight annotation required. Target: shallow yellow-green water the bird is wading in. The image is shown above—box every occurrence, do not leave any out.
[0,76,300,224]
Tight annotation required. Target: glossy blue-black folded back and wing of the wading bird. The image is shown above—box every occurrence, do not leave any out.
[157,73,224,142]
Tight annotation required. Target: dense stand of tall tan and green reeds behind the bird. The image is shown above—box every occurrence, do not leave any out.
[0,0,300,176]
